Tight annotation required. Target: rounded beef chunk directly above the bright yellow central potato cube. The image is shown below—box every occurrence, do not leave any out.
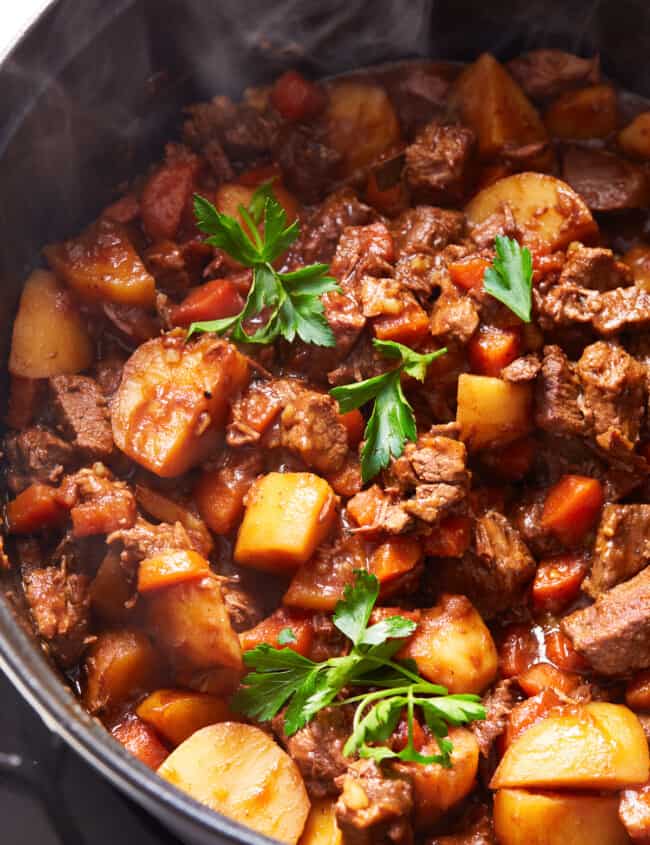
[280,390,348,474]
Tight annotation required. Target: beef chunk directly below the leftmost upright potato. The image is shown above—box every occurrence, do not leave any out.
[50,375,113,460]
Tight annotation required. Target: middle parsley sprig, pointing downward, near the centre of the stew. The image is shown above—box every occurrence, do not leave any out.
[330,340,447,482]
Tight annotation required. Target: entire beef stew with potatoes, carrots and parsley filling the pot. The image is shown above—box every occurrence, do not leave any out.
[6,50,650,845]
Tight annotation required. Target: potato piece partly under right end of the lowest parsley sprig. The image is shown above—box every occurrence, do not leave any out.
[407,728,479,830]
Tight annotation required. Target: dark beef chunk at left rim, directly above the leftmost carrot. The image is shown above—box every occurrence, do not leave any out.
[5,427,78,493]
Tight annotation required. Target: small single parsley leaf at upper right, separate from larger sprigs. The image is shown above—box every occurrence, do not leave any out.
[483,235,533,323]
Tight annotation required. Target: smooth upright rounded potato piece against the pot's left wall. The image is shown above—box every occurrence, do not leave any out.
[9,270,94,379]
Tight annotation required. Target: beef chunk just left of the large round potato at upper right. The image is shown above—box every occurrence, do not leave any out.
[392,205,465,257]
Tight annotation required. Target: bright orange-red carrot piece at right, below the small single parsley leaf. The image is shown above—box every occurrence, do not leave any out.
[541,475,605,546]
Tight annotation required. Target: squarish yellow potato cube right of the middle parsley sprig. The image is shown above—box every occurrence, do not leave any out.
[456,373,533,452]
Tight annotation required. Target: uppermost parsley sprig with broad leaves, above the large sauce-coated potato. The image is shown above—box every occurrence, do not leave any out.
[188,182,338,346]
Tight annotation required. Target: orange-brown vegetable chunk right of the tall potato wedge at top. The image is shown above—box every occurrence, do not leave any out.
[544,85,618,140]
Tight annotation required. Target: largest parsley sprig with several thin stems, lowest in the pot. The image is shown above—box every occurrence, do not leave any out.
[232,570,485,767]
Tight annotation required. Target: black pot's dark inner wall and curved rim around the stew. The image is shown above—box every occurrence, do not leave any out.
[0,0,650,845]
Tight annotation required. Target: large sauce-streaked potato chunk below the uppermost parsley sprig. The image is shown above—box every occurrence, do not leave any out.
[112,332,249,478]
